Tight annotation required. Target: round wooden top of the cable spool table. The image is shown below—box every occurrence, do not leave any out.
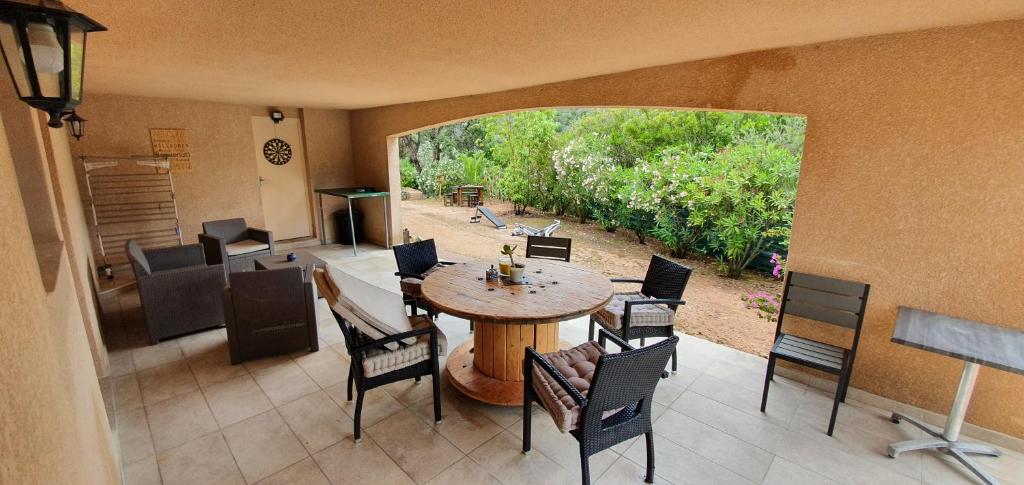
[421,259,612,324]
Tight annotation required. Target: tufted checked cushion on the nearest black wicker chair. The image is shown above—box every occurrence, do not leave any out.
[532,342,605,433]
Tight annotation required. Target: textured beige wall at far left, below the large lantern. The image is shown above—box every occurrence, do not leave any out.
[0,111,120,484]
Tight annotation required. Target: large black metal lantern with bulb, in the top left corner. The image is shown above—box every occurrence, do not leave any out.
[0,0,106,128]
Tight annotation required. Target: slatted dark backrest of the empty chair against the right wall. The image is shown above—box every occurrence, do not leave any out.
[775,271,871,333]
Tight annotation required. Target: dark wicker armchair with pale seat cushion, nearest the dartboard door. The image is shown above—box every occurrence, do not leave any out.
[199,219,273,272]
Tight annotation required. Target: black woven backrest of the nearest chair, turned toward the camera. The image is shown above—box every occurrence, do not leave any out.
[582,336,679,432]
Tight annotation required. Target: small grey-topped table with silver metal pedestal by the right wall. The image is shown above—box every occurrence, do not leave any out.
[889,307,1024,485]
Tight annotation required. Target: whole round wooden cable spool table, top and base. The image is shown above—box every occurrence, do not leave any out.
[422,260,612,406]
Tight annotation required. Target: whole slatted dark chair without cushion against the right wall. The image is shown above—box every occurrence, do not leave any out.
[761,271,871,436]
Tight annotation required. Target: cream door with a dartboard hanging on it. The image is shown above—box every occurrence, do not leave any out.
[252,117,312,240]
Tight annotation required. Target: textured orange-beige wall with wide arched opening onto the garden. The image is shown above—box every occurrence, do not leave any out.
[350,21,1024,436]
